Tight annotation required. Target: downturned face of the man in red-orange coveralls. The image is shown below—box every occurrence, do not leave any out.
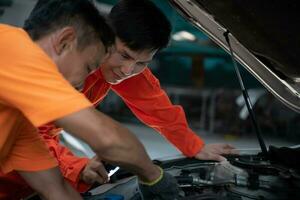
[101,38,156,84]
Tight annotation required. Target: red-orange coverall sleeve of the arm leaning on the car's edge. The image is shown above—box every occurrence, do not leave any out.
[112,68,204,157]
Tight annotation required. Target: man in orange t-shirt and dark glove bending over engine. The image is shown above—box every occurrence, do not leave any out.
[0,0,178,199]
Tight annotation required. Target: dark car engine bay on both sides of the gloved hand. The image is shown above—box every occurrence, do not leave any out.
[84,149,300,200]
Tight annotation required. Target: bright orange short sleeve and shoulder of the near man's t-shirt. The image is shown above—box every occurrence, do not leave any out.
[0,25,92,127]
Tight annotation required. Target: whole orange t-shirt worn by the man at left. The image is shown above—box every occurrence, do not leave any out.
[0,24,92,173]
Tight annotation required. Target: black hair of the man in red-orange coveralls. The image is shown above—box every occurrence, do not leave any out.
[109,0,172,51]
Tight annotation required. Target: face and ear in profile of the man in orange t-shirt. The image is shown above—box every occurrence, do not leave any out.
[49,27,108,90]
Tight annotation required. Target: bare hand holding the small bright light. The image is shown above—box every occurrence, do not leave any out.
[80,156,109,184]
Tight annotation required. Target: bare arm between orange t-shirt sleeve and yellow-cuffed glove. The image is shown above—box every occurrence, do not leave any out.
[57,109,160,181]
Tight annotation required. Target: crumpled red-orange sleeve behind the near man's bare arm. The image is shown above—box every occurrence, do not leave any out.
[40,133,91,193]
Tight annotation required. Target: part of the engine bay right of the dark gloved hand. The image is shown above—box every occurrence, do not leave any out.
[159,156,300,200]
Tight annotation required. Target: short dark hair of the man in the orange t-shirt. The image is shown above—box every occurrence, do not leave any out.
[24,0,115,49]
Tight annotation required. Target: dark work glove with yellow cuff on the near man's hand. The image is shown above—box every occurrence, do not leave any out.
[140,168,179,200]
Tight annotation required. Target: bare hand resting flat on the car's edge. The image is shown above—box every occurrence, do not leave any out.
[195,144,238,161]
